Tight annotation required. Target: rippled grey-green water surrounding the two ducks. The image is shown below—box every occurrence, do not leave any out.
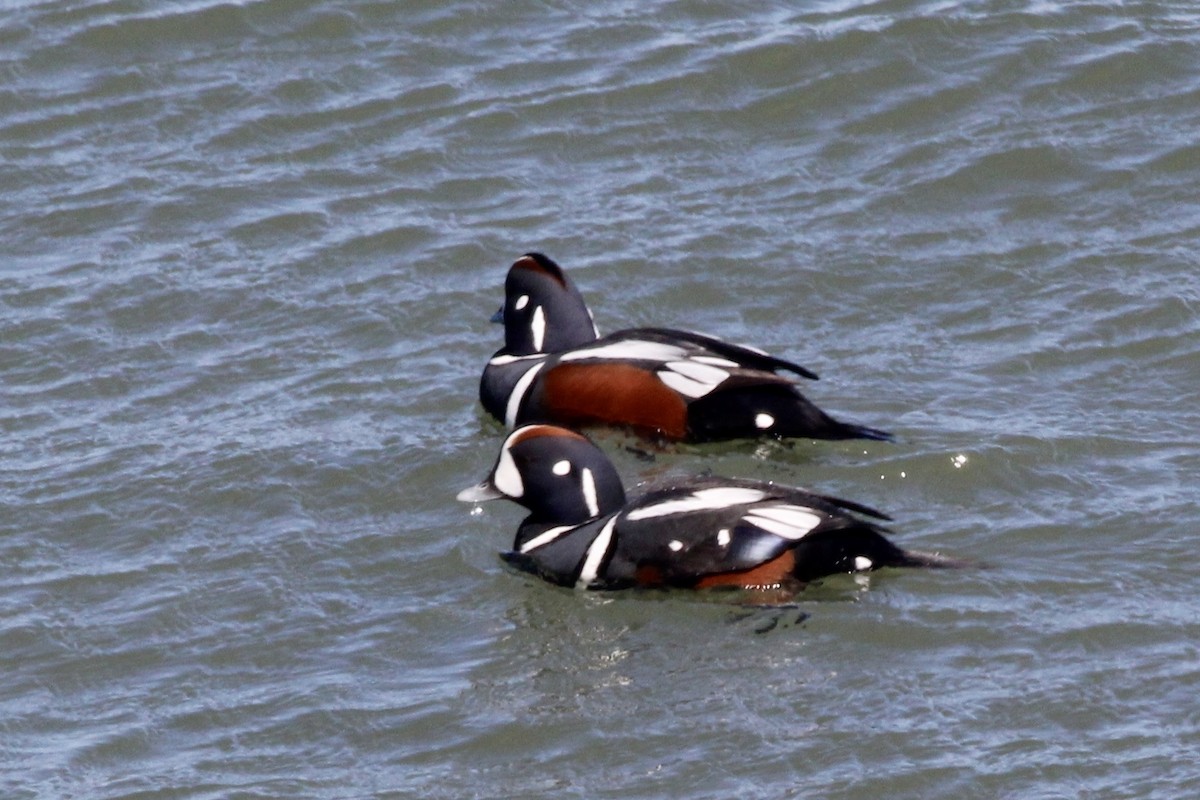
[0,0,1200,799]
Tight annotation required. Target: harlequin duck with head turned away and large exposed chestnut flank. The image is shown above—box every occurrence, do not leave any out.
[479,253,892,441]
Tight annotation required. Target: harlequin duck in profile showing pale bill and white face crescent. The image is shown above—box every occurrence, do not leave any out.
[458,425,961,591]
